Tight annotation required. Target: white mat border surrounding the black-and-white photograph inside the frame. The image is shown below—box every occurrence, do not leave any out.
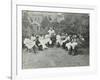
[12,4,96,80]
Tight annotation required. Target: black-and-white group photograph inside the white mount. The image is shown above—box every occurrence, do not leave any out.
[21,10,90,69]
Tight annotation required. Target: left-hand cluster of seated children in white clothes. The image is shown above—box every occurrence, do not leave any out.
[24,34,52,53]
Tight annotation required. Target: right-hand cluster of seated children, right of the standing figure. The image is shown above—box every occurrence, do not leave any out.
[56,34,84,55]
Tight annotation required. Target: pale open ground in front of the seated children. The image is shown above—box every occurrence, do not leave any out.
[22,47,89,69]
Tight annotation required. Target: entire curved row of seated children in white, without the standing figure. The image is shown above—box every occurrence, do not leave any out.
[24,33,84,55]
